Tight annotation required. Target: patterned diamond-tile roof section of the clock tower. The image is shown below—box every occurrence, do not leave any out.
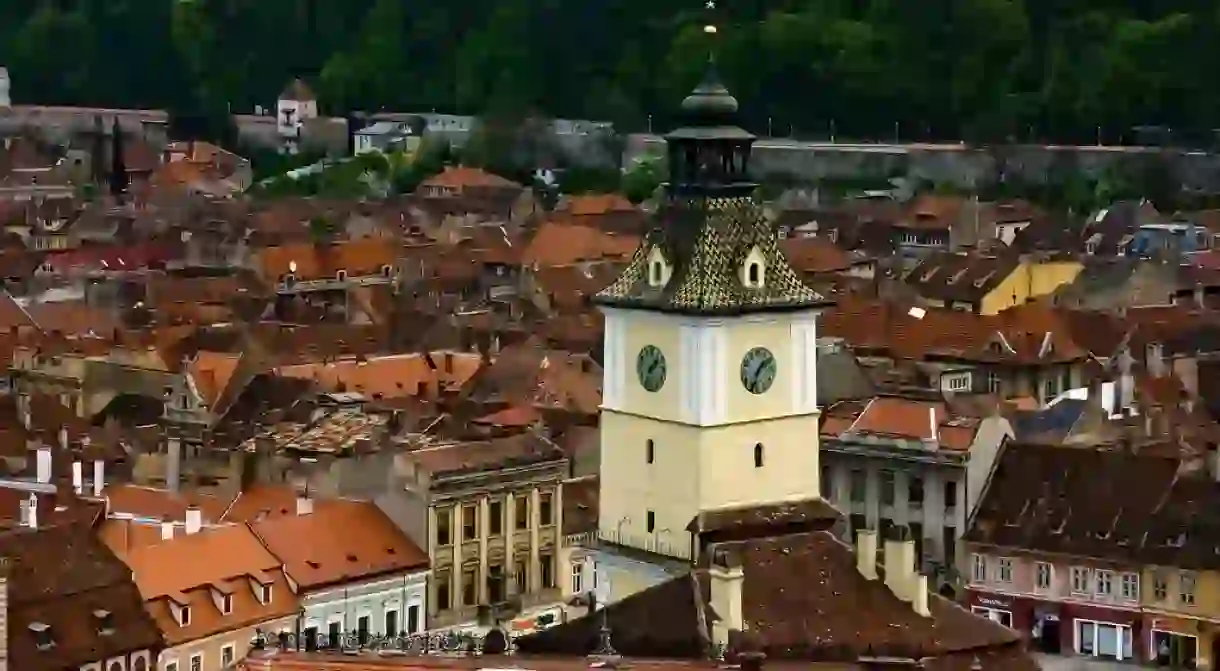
[594,195,828,315]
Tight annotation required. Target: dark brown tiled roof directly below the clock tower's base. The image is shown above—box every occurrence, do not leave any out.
[516,532,1037,670]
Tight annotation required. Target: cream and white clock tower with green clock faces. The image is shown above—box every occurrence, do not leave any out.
[594,50,826,559]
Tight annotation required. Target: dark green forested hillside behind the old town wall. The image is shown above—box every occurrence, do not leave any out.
[0,0,1220,142]
